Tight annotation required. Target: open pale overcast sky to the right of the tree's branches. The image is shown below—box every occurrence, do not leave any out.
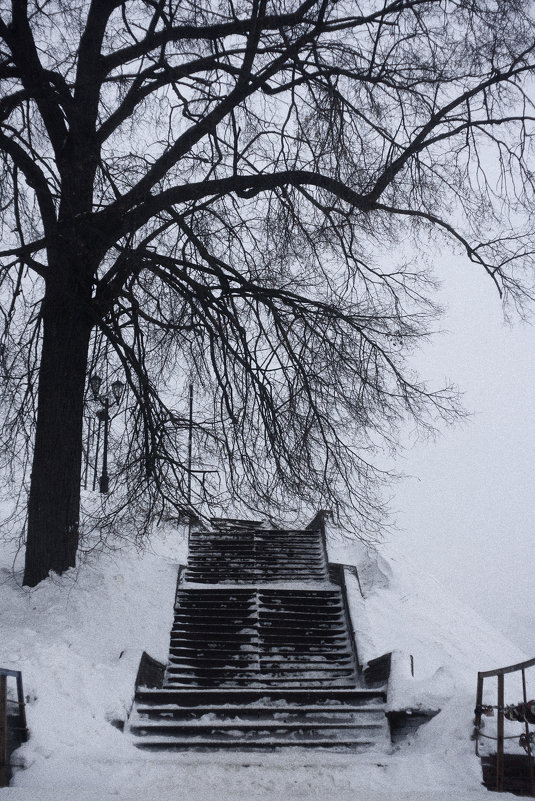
[394,248,535,656]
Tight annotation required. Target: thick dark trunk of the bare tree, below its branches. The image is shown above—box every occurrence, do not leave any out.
[24,265,91,587]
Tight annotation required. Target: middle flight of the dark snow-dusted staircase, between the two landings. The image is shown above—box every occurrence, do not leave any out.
[165,587,356,688]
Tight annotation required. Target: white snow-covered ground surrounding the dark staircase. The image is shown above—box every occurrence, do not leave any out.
[0,530,535,801]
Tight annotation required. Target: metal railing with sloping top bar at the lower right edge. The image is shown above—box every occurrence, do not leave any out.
[474,659,535,796]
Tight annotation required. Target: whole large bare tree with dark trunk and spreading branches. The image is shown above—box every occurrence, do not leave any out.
[0,0,535,585]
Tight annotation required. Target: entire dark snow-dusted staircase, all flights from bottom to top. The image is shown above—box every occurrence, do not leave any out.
[128,525,390,751]
